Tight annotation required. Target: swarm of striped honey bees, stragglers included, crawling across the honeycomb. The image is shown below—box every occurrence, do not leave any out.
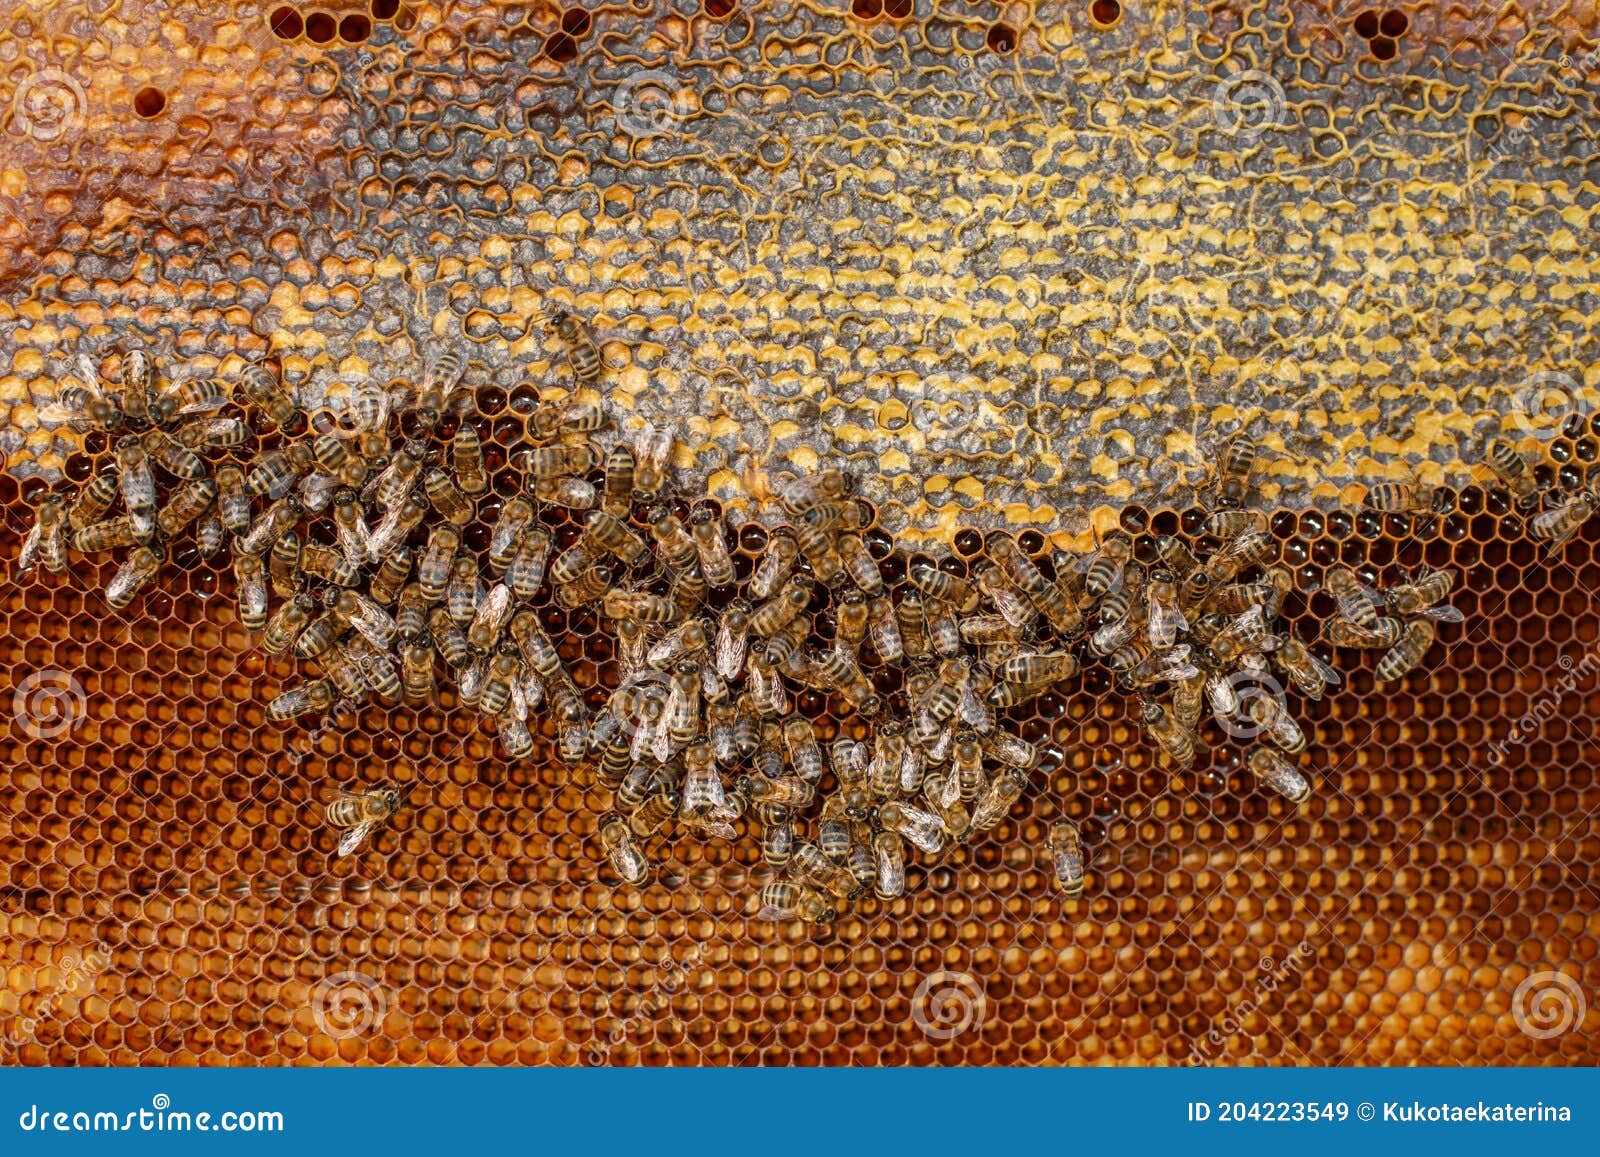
[22,326,1597,922]
